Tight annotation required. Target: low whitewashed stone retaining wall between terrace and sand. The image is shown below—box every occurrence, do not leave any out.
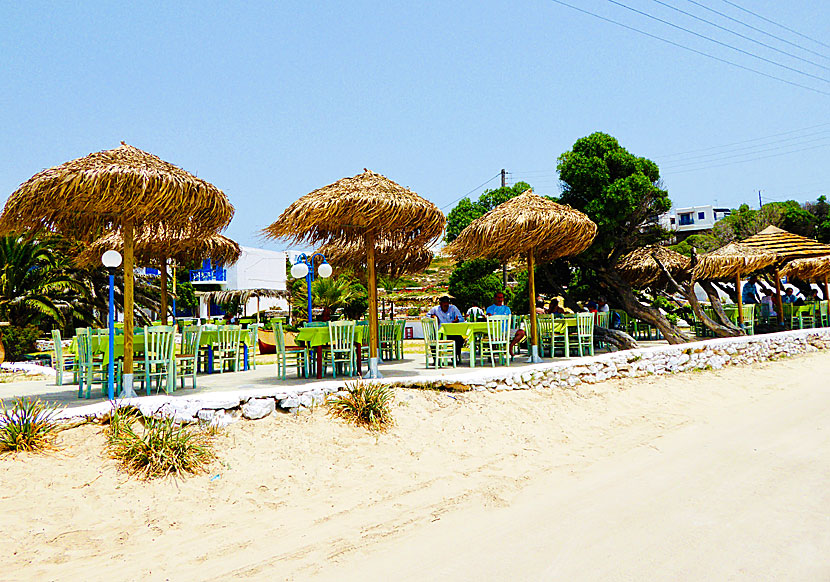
[60,328,830,426]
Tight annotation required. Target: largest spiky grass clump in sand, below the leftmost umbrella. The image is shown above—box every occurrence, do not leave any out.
[107,408,216,479]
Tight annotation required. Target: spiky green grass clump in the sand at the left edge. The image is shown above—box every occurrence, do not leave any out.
[0,398,60,452]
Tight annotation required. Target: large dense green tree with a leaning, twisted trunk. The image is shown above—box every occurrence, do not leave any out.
[557,132,688,343]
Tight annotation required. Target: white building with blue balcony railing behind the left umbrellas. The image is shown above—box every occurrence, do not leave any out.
[190,247,288,317]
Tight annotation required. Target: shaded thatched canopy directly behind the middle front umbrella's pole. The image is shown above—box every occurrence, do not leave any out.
[317,238,433,277]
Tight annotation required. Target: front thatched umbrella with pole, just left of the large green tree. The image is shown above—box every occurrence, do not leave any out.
[445,190,597,362]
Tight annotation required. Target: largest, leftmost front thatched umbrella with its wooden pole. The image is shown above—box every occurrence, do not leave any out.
[0,142,233,394]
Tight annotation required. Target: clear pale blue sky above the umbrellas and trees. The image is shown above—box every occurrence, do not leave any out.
[0,0,830,248]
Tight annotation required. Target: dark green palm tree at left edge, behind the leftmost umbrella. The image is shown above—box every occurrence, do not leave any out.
[0,236,89,327]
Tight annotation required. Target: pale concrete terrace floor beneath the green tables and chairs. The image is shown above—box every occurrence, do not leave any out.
[0,340,666,408]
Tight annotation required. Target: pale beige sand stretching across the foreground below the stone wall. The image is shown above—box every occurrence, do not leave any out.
[0,354,830,581]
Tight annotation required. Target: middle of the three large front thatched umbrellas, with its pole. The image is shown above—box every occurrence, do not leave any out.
[264,169,446,377]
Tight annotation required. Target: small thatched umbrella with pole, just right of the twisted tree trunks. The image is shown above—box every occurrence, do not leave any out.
[692,242,778,325]
